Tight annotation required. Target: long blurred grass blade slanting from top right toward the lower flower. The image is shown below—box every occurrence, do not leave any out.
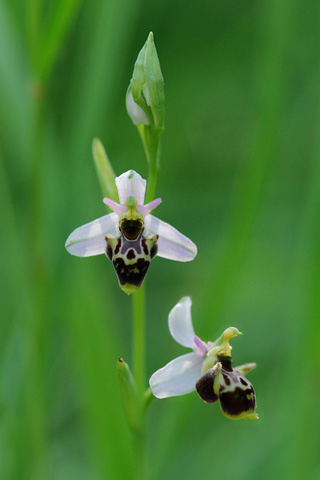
[202,0,297,334]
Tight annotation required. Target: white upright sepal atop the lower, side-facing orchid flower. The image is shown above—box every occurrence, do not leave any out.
[169,297,195,349]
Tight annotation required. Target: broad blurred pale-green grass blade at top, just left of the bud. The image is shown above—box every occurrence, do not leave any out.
[66,0,140,164]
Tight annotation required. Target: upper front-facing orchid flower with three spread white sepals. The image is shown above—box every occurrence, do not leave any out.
[65,170,197,295]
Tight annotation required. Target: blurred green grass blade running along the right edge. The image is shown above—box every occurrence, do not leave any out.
[281,77,320,480]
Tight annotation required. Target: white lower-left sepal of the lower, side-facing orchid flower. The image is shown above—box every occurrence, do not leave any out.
[149,352,202,398]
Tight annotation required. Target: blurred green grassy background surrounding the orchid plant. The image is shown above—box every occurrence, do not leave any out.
[0,0,320,480]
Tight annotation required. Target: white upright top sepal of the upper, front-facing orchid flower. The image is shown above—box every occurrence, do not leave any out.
[115,170,147,205]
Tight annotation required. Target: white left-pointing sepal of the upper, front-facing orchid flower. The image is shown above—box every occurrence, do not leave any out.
[65,213,119,257]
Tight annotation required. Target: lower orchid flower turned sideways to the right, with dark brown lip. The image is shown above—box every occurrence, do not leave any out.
[149,297,258,419]
